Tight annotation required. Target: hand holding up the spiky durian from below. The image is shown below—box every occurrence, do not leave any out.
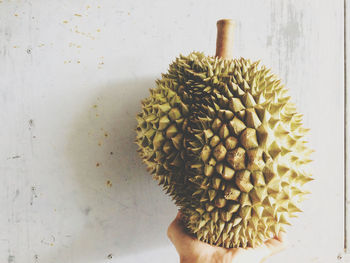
[167,212,285,263]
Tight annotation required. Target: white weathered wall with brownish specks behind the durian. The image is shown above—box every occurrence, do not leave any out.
[0,0,344,263]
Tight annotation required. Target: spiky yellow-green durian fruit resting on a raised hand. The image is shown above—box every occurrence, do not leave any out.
[136,20,312,248]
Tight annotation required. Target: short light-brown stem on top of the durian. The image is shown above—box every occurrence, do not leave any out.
[215,19,235,59]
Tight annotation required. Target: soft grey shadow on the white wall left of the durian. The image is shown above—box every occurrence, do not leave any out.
[47,79,176,262]
